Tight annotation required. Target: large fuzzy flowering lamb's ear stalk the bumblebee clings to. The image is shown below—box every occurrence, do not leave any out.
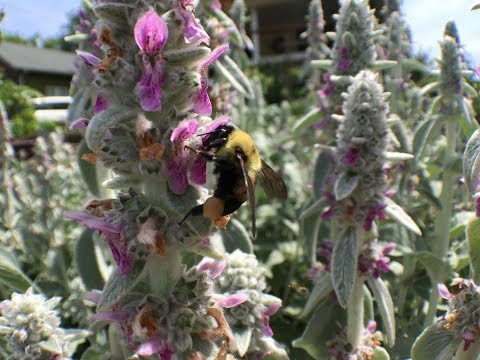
[63,0,288,359]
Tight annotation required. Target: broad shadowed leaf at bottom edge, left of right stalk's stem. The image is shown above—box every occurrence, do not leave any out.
[292,301,340,360]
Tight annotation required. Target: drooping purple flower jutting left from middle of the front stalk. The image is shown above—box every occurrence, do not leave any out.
[67,211,134,275]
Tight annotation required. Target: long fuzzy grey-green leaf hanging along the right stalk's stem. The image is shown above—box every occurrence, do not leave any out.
[332,227,361,308]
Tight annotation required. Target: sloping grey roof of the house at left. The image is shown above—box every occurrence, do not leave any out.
[0,42,76,75]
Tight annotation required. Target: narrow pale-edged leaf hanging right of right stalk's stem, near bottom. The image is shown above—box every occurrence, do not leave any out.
[368,278,395,346]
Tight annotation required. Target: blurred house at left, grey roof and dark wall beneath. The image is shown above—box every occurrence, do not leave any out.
[0,42,76,96]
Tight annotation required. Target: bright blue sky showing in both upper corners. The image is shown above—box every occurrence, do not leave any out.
[0,0,480,64]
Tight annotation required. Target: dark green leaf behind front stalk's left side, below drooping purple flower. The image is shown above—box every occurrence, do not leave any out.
[73,229,105,289]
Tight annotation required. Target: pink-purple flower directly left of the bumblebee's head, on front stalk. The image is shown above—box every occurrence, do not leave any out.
[167,119,198,195]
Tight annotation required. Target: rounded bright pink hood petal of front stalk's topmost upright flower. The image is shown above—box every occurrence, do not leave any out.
[133,10,168,56]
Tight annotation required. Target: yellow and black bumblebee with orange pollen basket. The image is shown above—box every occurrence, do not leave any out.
[180,125,287,237]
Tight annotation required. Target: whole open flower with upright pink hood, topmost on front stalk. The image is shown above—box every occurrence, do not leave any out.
[134,10,168,111]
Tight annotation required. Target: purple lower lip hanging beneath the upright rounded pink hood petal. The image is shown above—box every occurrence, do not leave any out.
[136,59,163,111]
